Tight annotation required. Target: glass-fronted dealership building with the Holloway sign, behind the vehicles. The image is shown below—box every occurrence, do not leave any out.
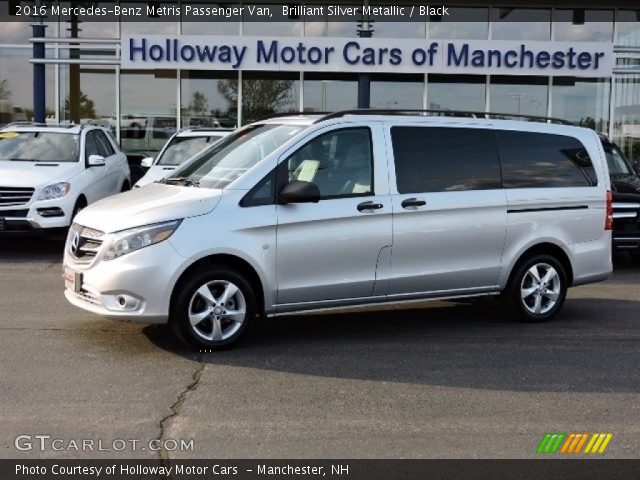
[0,1,640,160]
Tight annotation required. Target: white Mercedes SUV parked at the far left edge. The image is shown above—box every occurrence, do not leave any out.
[0,122,131,233]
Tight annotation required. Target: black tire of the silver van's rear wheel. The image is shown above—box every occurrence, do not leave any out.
[504,254,568,323]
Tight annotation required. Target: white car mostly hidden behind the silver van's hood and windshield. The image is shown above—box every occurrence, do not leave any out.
[135,128,233,187]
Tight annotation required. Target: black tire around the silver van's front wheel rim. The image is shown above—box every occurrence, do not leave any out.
[169,265,257,350]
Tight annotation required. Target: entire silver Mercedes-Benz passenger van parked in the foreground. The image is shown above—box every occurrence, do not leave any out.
[64,111,612,348]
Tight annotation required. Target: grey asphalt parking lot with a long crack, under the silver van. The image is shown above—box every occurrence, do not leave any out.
[0,238,640,458]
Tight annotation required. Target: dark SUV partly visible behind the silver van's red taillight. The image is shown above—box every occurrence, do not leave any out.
[600,135,640,260]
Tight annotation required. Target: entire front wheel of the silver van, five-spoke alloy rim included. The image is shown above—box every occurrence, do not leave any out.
[169,266,256,349]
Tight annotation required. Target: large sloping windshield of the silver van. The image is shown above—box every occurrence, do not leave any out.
[174,124,306,188]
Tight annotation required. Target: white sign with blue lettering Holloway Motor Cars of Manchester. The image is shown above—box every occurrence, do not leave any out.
[121,35,614,77]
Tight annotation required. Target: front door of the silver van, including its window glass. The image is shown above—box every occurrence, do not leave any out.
[277,126,391,311]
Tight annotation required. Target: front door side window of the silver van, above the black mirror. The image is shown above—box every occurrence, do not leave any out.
[278,128,373,199]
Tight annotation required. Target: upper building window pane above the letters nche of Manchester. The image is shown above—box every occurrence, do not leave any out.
[491,7,551,40]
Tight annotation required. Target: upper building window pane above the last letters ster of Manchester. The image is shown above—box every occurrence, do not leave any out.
[553,8,613,42]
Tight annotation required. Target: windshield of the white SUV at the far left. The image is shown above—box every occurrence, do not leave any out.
[0,132,78,162]
